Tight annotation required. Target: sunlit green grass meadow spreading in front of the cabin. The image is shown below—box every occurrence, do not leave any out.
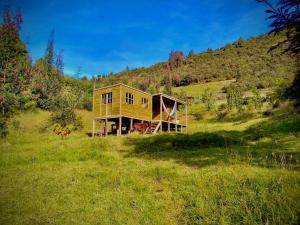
[0,107,300,224]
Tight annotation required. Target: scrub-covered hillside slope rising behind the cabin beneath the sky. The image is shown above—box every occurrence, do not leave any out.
[97,31,297,92]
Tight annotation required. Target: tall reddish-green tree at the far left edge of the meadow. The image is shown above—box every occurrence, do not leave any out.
[0,3,31,136]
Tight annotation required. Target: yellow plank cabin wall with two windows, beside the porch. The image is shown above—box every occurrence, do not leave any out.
[121,86,152,121]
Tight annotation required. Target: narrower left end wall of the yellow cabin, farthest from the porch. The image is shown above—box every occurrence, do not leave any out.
[93,85,120,117]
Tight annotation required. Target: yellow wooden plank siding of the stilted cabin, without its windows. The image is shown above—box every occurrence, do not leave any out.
[93,84,185,124]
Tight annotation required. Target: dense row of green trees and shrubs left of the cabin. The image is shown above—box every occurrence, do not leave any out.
[0,6,93,137]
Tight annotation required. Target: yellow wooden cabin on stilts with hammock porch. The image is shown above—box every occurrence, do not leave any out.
[93,84,187,136]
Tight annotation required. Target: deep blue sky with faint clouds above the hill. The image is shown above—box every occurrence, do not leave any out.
[1,0,274,77]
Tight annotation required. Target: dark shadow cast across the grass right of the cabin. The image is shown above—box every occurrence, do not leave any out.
[126,116,300,169]
